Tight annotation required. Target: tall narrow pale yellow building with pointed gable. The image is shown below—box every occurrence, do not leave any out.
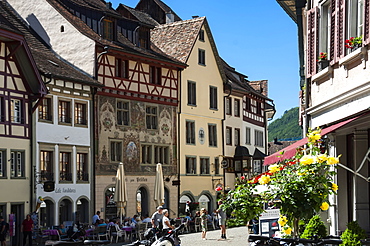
[151,17,225,214]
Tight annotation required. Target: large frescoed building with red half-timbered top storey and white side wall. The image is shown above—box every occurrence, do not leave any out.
[10,0,185,218]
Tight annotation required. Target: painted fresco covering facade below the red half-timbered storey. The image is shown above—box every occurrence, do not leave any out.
[96,96,176,175]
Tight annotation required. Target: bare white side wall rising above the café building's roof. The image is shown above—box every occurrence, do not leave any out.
[8,0,95,76]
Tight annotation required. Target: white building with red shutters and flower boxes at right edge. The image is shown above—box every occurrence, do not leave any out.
[278,0,370,235]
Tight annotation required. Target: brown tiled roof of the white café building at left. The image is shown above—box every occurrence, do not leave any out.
[0,1,101,86]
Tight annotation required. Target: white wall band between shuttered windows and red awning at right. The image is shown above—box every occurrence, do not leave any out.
[308,49,370,127]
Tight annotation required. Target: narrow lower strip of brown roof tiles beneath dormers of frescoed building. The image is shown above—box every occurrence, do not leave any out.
[46,0,184,66]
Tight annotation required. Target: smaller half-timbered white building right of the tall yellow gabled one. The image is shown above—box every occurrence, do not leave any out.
[222,60,275,189]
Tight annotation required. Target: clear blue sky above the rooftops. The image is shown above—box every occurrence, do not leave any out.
[112,0,299,120]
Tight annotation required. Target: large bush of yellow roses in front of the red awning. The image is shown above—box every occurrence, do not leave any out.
[269,129,340,236]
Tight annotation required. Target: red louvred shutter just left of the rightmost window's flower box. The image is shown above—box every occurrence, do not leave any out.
[336,0,346,59]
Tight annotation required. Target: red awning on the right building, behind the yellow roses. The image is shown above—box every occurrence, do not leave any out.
[263,116,360,166]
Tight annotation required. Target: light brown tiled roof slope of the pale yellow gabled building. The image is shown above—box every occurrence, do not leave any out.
[150,17,205,63]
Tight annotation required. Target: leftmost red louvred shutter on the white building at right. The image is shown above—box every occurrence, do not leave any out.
[307,7,319,78]
